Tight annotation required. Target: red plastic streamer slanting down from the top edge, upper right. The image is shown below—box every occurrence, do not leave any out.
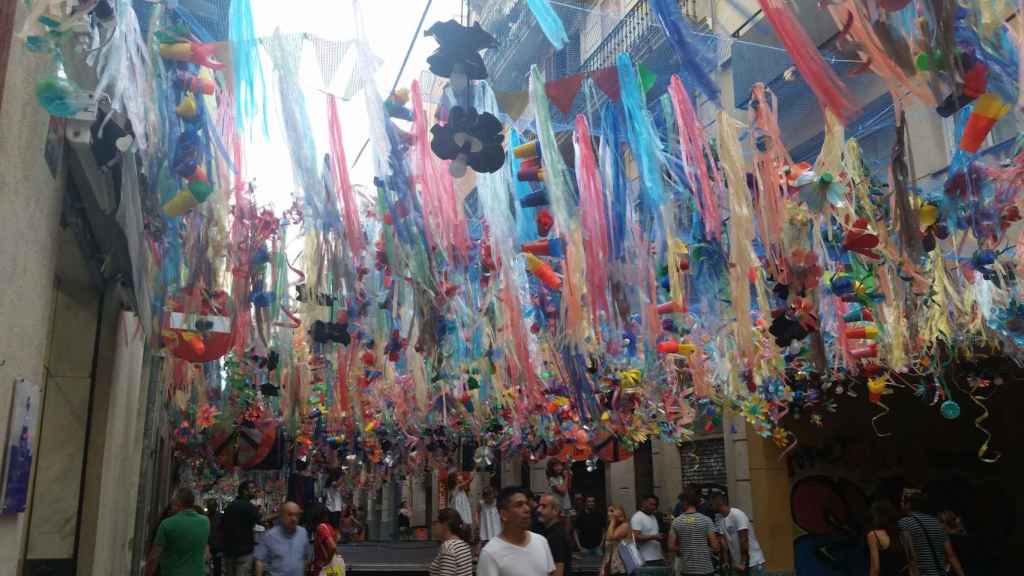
[757,0,857,124]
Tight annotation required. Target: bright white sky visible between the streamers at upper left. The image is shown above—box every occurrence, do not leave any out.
[247,0,463,212]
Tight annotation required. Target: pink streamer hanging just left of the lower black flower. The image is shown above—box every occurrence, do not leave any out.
[412,82,469,259]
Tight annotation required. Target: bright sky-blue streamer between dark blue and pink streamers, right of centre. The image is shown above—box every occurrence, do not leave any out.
[616,52,665,222]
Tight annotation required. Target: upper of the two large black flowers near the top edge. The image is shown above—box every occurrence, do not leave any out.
[423,19,498,80]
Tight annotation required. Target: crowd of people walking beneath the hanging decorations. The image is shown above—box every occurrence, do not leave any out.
[145,465,967,576]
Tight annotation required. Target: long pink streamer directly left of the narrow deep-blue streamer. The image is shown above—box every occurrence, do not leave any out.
[572,114,610,330]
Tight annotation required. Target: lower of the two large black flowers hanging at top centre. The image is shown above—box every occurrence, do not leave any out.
[430,106,505,177]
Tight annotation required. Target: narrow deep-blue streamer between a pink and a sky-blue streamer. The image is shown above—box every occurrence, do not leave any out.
[599,101,630,261]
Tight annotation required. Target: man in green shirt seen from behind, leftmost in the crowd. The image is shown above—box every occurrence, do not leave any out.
[145,487,210,576]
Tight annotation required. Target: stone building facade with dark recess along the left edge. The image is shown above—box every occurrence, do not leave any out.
[0,2,156,576]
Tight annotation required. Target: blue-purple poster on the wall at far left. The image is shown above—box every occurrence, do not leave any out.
[0,378,40,516]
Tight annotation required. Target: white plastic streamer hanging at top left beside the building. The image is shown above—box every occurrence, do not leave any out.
[90,0,157,151]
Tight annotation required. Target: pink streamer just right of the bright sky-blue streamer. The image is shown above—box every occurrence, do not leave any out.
[669,75,722,239]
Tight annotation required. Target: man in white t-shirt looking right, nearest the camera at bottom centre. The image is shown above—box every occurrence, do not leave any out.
[476,487,555,576]
